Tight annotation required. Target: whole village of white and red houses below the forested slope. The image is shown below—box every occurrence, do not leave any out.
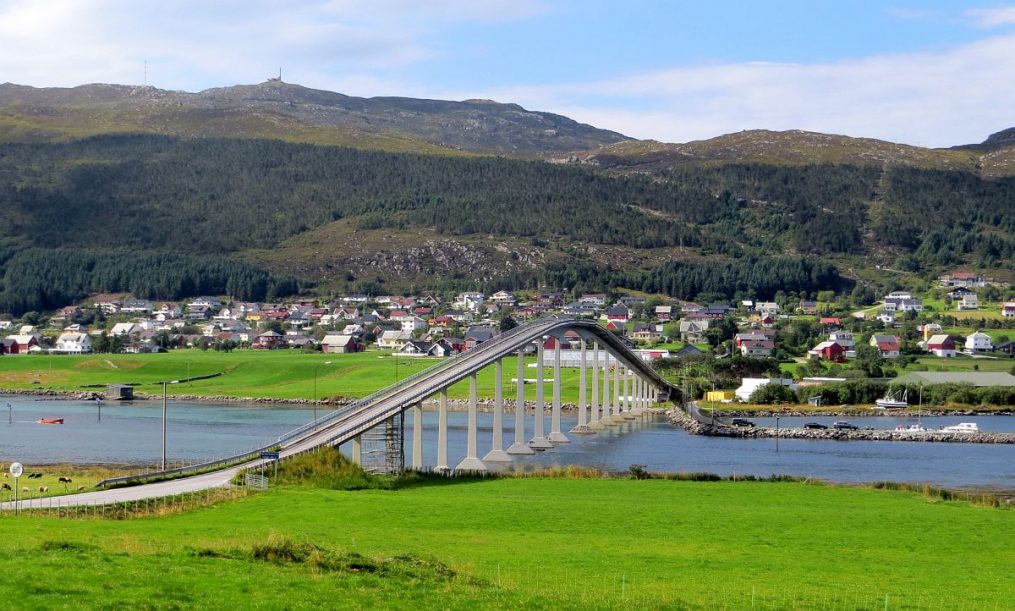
[0,272,1015,363]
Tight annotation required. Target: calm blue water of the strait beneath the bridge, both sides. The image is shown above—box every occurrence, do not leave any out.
[0,397,1015,488]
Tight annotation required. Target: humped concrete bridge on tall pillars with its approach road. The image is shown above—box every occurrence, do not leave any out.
[0,317,679,508]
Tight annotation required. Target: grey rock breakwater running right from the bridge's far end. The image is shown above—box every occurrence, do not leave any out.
[668,409,1015,444]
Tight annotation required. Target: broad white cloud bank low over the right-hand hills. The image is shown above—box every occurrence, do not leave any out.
[473,36,1015,146]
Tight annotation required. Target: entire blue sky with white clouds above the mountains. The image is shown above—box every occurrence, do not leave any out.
[0,0,1015,146]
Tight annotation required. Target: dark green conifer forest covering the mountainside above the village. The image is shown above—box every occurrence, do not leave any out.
[0,135,1015,313]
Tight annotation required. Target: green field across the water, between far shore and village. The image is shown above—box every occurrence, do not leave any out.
[0,350,591,402]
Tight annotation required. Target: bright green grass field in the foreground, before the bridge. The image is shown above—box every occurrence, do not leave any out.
[0,479,1015,609]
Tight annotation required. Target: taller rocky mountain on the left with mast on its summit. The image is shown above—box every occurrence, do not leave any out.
[0,80,628,155]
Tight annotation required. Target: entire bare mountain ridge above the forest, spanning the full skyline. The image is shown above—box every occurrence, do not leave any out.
[0,78,1015,173]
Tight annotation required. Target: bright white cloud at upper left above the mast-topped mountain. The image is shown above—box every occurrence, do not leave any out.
[0,0,545,89]
